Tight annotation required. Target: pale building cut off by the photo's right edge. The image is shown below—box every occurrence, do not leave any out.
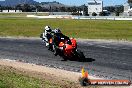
[124,3,132,16]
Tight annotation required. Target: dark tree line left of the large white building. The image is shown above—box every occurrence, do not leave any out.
[0,4,86,13]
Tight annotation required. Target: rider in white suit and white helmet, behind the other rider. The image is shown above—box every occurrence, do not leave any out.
[43,26,52,46]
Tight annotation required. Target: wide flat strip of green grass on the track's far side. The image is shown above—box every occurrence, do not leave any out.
[0,18,132,40]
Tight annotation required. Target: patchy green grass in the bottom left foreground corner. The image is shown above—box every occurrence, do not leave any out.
[0,66,61,88]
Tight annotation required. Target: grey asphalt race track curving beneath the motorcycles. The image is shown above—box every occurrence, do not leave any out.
[0,38,132,80]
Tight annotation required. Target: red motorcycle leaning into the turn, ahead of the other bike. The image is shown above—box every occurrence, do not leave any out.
[54,38,85,61]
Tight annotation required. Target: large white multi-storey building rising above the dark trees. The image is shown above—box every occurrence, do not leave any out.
[88,0,103,15]
